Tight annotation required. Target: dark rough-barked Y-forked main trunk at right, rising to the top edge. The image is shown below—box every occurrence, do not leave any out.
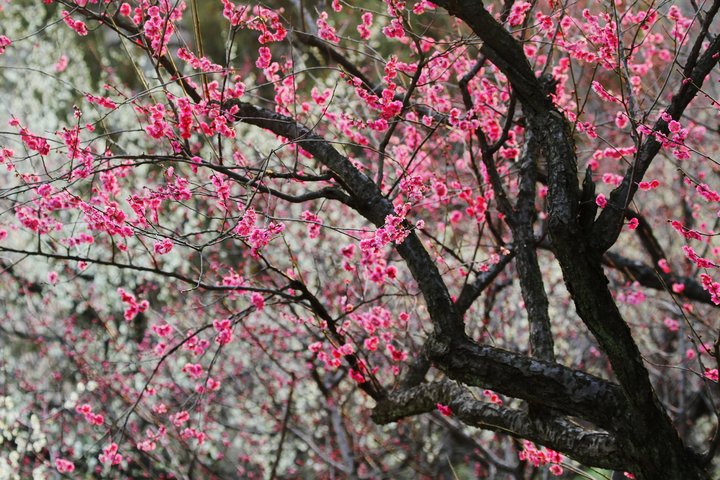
[436,0,720,479]
